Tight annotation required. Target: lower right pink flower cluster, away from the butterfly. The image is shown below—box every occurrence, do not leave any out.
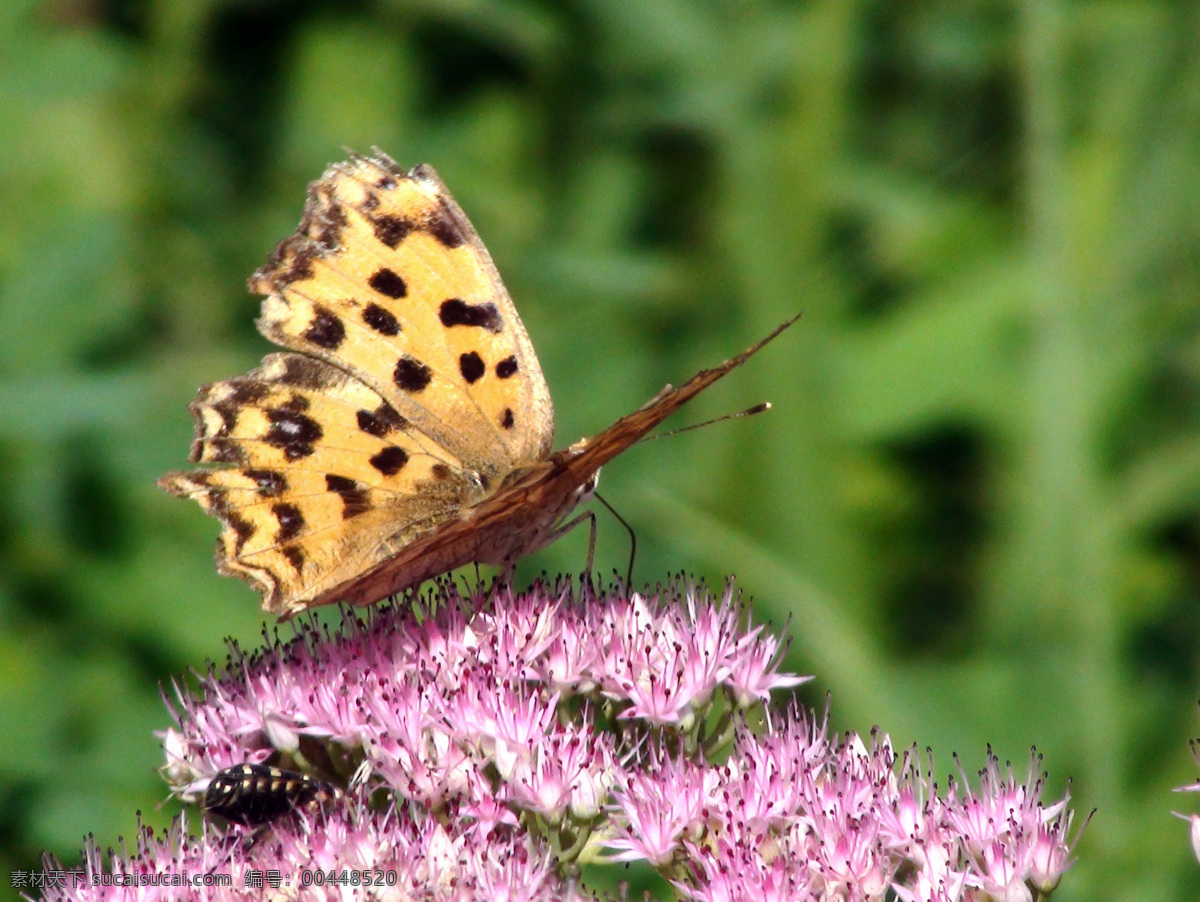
[606,710,1072,902]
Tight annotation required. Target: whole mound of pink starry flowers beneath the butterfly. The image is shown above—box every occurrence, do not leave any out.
[35,583,1072,902]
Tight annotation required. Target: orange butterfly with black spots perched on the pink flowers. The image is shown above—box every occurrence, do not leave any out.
[158,151,796,618]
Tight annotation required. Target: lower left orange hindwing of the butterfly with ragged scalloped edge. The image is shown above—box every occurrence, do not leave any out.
[162,354,482,613]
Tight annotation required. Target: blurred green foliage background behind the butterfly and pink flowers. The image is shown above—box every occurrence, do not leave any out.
[0,0,1200,902]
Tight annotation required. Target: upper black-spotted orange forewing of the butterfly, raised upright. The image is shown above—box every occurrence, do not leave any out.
[250,155,554,475]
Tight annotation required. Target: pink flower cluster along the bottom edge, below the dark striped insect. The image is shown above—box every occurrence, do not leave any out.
[42,799,580,902]
